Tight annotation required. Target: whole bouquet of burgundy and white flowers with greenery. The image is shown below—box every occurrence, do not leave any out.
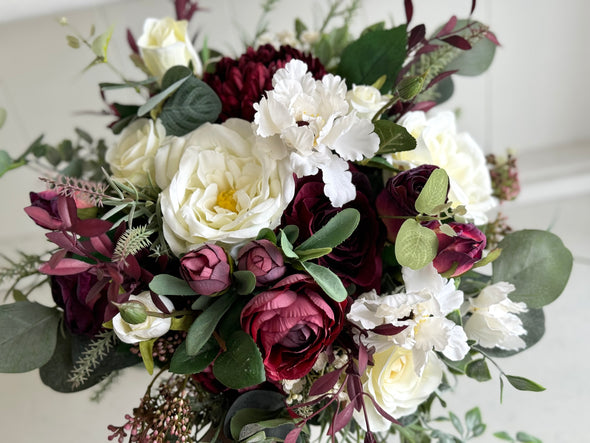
[0,0,572,443]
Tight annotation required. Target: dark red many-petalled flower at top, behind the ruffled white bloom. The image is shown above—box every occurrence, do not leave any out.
[203,45,326,122]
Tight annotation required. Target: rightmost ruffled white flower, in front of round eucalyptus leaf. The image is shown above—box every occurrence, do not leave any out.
[462,282,527,350]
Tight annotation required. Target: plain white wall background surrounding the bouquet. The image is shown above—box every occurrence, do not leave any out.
[0,0,590,443]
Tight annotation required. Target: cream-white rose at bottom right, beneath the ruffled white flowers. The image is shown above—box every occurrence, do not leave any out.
[353,346,443,432]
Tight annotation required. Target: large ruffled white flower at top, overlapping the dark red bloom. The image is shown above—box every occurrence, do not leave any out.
[254,60,379,207]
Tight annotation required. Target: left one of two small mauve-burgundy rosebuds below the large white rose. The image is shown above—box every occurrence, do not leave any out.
[180,244,231,295]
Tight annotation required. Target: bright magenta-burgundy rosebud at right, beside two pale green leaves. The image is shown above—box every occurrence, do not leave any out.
[426,221,486,277]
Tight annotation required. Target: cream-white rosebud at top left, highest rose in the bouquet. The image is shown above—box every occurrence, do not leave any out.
[137,17,203,79]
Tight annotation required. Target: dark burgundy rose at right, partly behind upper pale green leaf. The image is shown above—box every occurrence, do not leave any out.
[376,165,446,243]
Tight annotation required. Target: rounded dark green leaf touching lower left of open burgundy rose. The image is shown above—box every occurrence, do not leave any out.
[213,331,266,389]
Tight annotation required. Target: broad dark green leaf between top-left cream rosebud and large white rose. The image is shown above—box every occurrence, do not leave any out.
[159,76,221,136]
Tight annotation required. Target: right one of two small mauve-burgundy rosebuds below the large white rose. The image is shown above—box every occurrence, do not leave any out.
[238,239,285,286]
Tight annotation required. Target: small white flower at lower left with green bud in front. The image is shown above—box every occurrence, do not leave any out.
[113,291,174,344]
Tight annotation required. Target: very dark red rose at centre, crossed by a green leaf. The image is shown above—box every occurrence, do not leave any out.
[282,168,385,293]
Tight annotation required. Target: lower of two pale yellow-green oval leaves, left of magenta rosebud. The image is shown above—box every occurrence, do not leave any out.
[395,219,438,269]
